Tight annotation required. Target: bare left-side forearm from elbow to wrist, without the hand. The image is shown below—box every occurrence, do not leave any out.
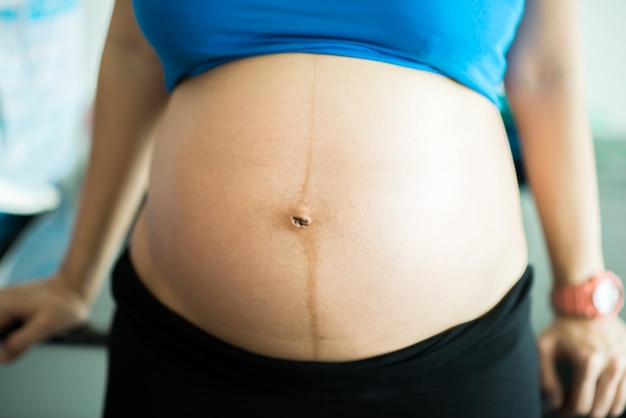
[61,43,165,300]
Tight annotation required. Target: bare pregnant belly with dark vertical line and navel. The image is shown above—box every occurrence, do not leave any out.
[131,54,527,361]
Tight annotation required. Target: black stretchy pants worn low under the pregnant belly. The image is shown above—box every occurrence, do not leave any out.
[104,253,541,418]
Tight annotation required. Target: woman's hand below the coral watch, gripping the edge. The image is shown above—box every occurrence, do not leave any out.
[538,317,626,418]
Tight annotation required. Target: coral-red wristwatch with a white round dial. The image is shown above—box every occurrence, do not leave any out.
[552,271,624,318]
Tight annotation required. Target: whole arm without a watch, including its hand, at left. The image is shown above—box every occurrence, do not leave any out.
[0,0,167,362]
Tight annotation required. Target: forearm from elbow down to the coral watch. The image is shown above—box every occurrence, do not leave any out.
[507,75,604,285]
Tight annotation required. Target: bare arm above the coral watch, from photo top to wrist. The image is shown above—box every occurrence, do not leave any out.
[505,0,604,285]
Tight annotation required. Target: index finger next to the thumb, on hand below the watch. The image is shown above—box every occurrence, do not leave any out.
[566,353,605,416]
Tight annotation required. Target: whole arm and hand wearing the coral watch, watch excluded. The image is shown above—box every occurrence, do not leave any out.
[505,0,626,417]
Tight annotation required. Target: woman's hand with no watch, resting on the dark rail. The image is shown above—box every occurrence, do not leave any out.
[0,276,89,363]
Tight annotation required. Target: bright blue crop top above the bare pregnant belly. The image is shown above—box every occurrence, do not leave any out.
[133,0,524,104]
